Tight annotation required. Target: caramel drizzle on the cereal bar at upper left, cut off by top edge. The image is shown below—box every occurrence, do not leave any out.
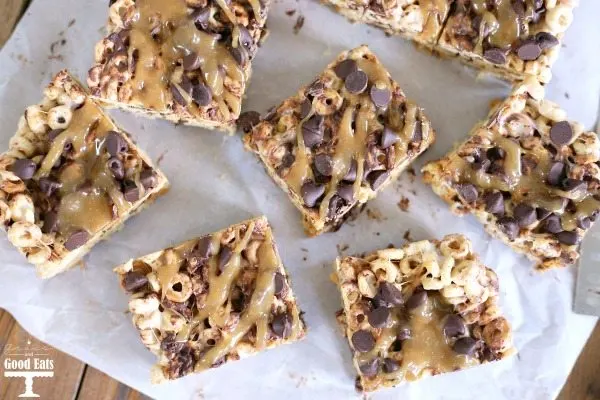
[129,0,246,119]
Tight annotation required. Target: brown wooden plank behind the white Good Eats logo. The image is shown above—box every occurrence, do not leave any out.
[0,311,85,399]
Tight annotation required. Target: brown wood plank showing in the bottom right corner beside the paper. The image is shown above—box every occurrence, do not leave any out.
[558,321,600,400]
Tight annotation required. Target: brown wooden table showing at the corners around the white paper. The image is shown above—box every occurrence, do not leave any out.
[0,0,600,400]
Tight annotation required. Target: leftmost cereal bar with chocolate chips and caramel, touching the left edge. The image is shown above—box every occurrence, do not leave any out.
[0,71,169,278]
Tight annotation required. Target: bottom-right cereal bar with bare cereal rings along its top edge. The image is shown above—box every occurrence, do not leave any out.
[334,234,515,391]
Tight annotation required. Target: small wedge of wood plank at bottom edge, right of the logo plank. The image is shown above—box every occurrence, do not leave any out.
[77,366,150,400]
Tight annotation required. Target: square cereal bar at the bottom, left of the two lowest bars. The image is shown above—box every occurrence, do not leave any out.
[115,217,306,383]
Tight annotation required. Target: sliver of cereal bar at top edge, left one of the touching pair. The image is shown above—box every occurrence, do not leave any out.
[322,0,451,47]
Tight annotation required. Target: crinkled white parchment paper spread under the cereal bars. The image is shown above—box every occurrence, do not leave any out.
[0,0,600,400]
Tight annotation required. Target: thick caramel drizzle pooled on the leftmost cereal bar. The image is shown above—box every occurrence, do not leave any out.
[34,100,131,237]
